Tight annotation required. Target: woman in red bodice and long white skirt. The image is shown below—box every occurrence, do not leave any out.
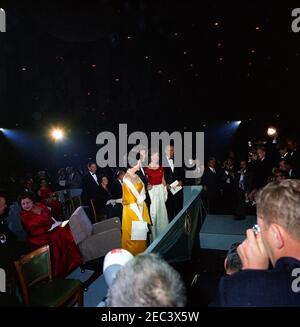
[145,150,169,241]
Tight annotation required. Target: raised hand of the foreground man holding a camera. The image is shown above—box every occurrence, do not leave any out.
[237,229,269,269]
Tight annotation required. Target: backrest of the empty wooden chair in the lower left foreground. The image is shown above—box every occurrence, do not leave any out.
[15,245,52,305]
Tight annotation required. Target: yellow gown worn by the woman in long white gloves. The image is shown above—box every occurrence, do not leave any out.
[122,181,150,255]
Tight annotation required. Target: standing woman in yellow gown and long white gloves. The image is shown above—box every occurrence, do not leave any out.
[122,160,150,255]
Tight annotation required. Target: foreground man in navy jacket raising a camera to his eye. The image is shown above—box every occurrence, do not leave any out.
[219,180,300,306]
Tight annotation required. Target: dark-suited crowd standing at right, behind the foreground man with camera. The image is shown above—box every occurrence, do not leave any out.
[200,138,300,219]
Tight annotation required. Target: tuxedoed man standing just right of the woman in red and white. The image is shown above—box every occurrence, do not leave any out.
[164,145,184,222]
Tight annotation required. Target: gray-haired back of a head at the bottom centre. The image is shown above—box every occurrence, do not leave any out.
[107,253,186,307]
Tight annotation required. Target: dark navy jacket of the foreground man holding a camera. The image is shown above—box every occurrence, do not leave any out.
[219,257,300,307]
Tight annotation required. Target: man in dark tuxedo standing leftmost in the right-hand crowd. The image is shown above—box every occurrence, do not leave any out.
[201,157,221,213]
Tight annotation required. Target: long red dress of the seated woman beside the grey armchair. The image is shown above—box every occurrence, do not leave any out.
[21,203,82,277]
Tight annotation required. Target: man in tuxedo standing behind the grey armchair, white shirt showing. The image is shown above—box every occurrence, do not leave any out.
[81,162,101,209]
